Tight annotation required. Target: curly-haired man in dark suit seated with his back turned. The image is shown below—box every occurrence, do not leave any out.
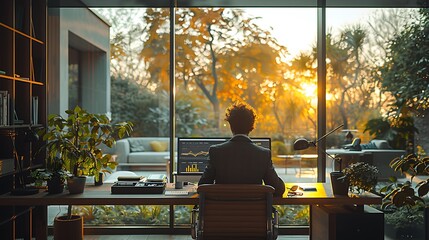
[198,103,285,196]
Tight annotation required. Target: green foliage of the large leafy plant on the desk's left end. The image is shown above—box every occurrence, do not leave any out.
[39,106,133,180]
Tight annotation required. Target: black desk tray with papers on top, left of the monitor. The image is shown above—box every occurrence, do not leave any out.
[111,181,165,194]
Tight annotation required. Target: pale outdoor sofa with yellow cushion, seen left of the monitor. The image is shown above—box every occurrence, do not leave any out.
[114,137,170,170]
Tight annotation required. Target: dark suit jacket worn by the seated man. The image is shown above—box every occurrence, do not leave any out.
[198,135,285,196]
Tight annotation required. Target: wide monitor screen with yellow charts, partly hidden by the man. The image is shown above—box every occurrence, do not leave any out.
[177,138,271,175]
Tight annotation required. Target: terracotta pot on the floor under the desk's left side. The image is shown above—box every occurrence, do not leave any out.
[54,215,83,240]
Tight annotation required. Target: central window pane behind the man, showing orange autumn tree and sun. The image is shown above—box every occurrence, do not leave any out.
[176,8,317,186]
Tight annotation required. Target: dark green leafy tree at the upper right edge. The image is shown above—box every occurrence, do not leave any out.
[380,8,429,115]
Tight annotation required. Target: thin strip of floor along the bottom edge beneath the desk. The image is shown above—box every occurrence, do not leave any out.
[48,235,309,240]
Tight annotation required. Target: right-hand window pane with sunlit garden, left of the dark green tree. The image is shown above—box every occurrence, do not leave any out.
[326,8,418,173]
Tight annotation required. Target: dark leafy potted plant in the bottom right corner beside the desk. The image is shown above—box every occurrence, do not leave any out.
[380,154,429,238]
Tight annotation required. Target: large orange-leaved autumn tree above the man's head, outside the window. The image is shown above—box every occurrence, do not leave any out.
[142,8,285,129]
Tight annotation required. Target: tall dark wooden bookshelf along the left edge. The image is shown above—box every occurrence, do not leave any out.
[0,0,47,239]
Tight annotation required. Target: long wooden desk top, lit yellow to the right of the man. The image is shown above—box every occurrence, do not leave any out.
[0,183,382,206]
